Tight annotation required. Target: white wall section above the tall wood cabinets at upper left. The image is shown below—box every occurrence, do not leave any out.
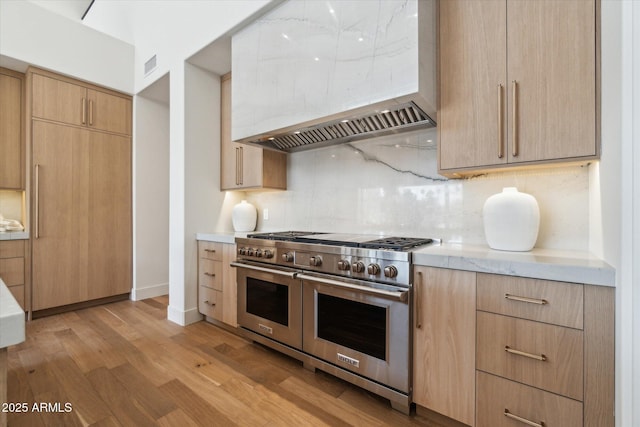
[0,0,134,94]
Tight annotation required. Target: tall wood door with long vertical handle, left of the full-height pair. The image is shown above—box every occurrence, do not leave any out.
[32,121,90,310]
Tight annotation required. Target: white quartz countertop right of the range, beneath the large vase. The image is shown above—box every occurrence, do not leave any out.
[413,243,616,286]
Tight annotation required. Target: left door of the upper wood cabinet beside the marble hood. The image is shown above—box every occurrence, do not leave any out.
[438,0,507,170]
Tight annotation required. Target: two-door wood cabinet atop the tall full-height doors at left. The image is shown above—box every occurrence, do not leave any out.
[30,70,132,135]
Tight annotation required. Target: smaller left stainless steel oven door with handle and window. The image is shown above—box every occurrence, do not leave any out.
[231,261,302,349]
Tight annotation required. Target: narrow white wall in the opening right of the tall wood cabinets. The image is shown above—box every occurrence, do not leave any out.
[131,75,169,300]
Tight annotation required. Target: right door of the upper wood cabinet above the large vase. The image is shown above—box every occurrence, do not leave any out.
[508,0,597,163]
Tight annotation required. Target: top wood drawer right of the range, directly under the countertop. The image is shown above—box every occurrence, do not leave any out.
[477,274,584,329]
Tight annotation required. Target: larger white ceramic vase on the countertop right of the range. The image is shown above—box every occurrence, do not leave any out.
[482,187,540,252]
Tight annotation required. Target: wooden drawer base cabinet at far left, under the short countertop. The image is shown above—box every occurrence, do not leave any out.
[0,240,29,310]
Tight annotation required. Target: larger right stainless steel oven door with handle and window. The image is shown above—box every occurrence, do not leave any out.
[298,274,411,393]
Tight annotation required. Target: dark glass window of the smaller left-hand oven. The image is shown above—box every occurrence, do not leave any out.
[247,277,289,326]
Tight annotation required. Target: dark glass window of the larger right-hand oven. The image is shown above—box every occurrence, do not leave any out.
[317,293,387,360]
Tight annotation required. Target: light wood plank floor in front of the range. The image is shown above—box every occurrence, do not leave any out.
[8,297,462,427]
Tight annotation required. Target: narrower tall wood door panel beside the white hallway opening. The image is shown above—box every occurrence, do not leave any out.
[87,132,132,300]
